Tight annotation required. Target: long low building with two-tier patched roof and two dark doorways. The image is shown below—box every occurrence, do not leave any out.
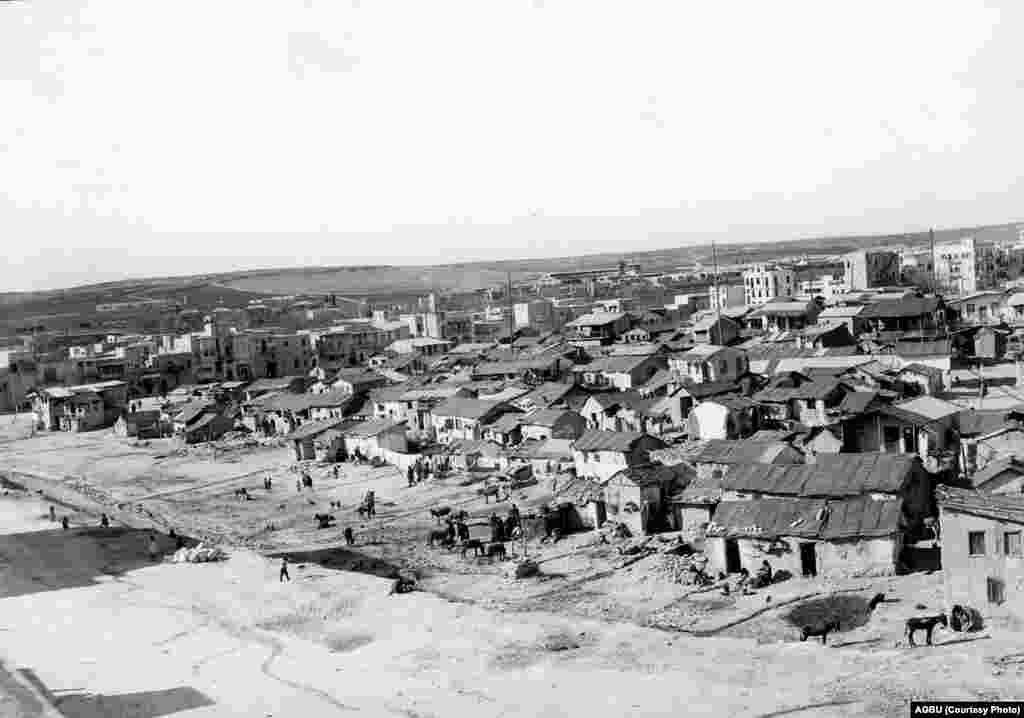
[705,454,934,576]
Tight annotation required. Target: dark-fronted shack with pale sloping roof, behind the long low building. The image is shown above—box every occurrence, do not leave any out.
[843,396,961,473]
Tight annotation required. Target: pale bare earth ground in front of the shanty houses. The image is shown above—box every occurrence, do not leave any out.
[0,419,1024,718]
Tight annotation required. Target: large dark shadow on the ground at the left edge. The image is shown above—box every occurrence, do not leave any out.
[0,526,174,598]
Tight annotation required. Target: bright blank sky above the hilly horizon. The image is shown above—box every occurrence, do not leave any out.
[0,0,1024,291]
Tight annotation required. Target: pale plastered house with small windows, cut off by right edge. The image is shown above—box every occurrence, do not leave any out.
[936,487,1024,621]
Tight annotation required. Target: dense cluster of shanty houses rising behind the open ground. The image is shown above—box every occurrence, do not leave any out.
[18,239,1024,622]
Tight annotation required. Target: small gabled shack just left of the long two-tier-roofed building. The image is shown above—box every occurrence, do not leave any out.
[598,465,692,536]
